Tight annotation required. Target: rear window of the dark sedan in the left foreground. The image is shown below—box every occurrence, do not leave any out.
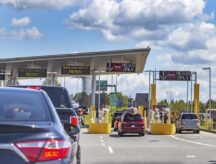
[0,91,52,121]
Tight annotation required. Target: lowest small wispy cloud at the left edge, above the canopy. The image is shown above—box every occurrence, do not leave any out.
[0,27,44,40]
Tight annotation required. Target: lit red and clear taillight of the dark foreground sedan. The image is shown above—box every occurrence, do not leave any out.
[15,139,70,162]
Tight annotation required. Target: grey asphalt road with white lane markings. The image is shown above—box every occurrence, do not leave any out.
[81,129,216,164]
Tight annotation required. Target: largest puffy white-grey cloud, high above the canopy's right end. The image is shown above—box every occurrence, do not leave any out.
[69,0,207,41]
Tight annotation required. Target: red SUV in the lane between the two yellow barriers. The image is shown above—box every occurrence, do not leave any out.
[118,112,145,136]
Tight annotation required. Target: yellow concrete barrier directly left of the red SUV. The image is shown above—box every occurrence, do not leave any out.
[88,123,111,134]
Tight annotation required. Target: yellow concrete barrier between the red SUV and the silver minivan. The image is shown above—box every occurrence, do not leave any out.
[151,123,176,135]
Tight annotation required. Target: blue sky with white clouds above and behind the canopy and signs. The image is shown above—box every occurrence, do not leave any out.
[0,0,216,100]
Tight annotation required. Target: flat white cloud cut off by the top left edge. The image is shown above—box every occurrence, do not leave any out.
[0,0,88,9]
